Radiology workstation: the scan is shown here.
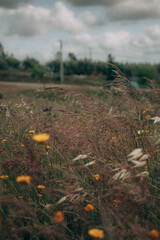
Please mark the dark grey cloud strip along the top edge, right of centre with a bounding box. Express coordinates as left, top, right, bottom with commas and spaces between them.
66, 0, 126, 7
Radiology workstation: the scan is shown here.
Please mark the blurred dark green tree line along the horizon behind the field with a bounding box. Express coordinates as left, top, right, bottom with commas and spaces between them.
0, 43, 160, 84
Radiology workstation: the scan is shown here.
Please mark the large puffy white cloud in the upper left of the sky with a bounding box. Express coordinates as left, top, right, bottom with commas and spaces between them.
0, 2, 86, 37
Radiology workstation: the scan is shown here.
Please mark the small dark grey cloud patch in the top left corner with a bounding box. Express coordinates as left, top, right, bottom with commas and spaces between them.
0, 0, 33, 8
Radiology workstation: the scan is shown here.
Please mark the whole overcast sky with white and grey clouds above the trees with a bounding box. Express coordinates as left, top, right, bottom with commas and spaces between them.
0, 0, 160, 63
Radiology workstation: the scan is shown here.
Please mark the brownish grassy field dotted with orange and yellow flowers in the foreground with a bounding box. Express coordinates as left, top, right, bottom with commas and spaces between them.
0, 73, 160, 240
